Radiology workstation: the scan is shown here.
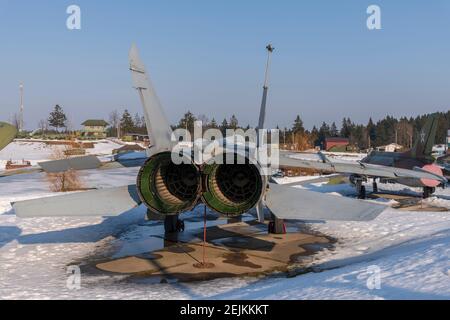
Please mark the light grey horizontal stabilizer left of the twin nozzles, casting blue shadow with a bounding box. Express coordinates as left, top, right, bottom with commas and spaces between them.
12, 185, 141, 218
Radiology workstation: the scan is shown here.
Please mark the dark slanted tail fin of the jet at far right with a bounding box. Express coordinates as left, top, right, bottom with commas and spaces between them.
411, 113, 439, 158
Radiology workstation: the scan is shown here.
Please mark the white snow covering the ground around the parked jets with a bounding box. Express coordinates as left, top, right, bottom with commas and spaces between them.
0, 144, 450, 300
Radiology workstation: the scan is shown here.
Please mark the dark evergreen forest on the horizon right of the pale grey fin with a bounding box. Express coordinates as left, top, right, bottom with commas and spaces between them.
172, 111, 450, 150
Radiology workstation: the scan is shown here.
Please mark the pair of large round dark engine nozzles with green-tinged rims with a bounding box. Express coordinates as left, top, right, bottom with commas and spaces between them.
137, 152, 267, 216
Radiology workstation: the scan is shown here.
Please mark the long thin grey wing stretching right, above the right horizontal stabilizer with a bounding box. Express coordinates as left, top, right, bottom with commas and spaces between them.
279, 152, 448, 184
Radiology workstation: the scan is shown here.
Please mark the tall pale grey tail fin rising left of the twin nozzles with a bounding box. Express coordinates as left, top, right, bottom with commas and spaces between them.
129, 44, 172, 156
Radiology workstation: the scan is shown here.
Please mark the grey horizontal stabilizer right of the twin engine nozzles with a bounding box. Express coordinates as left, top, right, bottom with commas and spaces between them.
266, 183, 387, 221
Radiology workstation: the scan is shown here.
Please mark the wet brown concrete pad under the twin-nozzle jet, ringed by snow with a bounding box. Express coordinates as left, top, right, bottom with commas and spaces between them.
97, 222, 330, 281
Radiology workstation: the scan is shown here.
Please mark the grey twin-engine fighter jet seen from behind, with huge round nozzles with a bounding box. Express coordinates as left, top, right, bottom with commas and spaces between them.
13, 46, 386, 230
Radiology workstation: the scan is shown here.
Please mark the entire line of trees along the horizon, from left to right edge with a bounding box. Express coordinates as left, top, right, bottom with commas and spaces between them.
33, 105, 450, 150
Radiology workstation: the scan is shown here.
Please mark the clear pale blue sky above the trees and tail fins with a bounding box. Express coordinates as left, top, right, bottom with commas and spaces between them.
0, 0, 450, 128
